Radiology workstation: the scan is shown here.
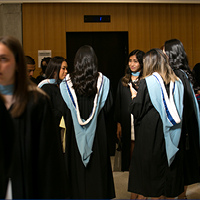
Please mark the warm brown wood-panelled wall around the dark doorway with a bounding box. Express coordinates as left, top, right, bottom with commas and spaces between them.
22, 3, 200, 76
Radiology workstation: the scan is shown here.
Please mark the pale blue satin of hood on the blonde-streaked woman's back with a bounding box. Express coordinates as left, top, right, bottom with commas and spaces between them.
145, 76, 184, 166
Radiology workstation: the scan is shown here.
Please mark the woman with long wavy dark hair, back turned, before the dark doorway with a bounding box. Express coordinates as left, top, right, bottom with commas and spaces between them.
60, 45, 115, 199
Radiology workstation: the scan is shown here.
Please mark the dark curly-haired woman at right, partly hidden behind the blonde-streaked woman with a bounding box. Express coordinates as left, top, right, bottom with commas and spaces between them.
164, 39, 200, 199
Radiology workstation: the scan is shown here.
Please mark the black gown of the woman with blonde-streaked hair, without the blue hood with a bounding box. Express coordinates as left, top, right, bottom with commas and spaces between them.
128, 79, 184, 197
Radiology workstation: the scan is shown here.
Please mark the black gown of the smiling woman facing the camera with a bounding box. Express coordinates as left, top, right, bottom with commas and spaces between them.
114, 79, 132, 171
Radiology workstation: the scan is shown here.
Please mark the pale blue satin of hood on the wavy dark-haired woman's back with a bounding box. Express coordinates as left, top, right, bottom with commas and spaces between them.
60, 75, 110, 167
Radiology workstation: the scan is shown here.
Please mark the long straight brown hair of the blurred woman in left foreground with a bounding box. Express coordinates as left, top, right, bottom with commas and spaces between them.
0, 36, 32, 117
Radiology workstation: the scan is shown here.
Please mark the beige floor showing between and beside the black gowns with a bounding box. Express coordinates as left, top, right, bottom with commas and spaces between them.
111, 156, 200, 199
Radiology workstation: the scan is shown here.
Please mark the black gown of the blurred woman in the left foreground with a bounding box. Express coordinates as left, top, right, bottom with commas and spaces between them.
11, 89, 68, 199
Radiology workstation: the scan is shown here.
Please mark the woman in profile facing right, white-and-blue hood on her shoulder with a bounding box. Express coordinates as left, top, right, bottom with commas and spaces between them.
38, 56, 68, 145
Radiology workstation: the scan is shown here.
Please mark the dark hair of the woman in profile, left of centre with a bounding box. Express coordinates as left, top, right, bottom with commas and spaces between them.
46, 56, 67, 85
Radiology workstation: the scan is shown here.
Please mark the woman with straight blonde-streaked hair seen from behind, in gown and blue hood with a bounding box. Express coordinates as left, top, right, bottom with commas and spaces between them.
128, 49, 184, 198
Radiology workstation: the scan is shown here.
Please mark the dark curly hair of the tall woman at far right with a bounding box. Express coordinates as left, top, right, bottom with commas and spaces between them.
164, 39, 195, 85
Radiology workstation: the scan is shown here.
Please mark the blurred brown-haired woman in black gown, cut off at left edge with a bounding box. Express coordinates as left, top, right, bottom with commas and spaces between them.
0, 36, 67, 199
